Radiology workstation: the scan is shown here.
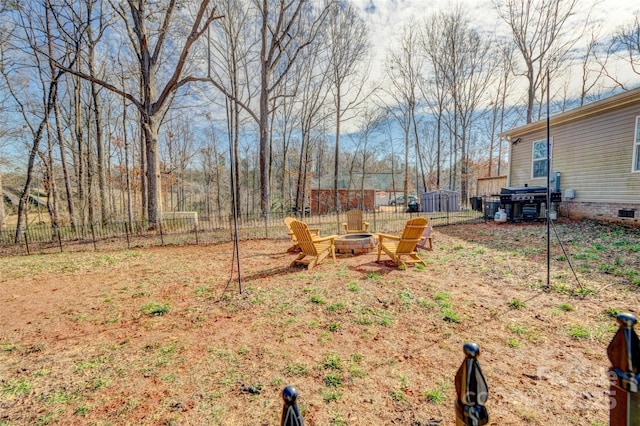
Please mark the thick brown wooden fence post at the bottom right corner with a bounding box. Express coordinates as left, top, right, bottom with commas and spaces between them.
607, 313, 640, 426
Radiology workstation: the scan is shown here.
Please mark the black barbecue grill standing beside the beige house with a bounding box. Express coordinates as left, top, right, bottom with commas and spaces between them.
500, 186, 562, 222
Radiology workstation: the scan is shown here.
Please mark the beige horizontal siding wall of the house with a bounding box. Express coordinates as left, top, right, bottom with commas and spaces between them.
504, 89, 640, 223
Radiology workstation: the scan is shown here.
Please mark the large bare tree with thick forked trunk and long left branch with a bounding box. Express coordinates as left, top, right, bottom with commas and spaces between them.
49, 0, 222, 228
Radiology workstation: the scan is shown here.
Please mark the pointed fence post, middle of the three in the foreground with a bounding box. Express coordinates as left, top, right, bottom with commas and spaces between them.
455, 343, 489, 426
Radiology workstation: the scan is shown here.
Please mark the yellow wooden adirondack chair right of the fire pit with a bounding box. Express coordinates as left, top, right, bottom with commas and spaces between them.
376, 217, 429, 267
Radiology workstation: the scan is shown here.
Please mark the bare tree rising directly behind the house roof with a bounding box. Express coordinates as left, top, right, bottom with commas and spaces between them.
494, 0, 582, 123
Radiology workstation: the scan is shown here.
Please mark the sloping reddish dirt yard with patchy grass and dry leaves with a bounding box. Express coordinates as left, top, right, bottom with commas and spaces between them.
0, 223, 640, 426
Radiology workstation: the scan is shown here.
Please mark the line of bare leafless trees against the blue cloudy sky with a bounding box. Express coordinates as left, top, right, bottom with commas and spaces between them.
0, 0, 640, 240
